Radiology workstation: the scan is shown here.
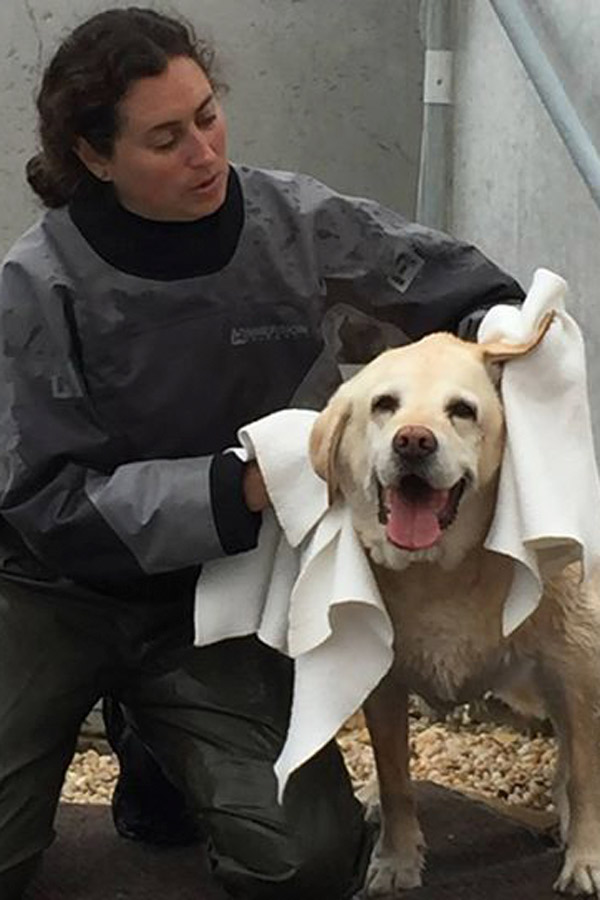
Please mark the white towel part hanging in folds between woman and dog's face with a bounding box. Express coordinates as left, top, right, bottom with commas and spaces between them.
195, 410, 393, 797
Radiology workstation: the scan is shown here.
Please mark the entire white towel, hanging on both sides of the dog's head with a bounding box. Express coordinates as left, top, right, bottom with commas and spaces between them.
195, 270, 600, 795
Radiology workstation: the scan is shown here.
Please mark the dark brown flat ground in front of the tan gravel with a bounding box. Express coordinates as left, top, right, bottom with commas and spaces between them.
26, 782, 560, 900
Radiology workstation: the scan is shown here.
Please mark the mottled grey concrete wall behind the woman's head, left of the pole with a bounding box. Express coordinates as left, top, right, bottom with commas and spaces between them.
0, 0, 422, 254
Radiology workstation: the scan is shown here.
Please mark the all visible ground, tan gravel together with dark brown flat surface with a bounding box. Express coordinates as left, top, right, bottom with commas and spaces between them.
26, 709, 561, 900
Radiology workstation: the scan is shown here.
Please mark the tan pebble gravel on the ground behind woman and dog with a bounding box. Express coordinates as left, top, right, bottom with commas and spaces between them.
62, 707, 556, 810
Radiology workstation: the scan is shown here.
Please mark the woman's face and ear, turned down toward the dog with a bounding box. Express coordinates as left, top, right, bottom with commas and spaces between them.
77, 56, 228, 221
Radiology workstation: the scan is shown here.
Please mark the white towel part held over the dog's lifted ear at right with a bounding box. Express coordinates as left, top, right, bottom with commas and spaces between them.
478, 269, 600, 634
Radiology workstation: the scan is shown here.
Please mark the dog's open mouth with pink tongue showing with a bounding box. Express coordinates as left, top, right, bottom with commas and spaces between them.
379, 475, 467, 550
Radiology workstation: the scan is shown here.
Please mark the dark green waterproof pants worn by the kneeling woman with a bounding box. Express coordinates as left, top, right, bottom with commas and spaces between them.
0, 582, 368, 900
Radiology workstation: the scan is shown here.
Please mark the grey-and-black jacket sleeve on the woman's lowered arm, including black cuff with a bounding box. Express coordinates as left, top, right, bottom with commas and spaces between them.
0, 260, 260, 583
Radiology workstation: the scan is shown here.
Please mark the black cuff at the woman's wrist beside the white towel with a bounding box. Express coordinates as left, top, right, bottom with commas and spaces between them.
210, 453, 262, 555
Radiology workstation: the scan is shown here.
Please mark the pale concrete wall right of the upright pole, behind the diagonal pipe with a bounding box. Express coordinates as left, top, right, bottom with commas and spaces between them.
452, 0, 600, 432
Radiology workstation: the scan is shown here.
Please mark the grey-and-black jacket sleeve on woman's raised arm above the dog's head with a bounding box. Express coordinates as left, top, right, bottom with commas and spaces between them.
300, 179, 524, 340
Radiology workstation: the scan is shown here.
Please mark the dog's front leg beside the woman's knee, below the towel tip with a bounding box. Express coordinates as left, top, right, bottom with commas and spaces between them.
365, 671, 425, 897
